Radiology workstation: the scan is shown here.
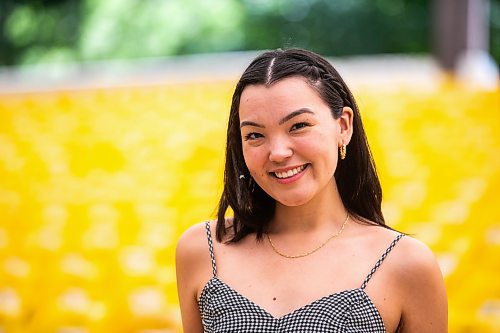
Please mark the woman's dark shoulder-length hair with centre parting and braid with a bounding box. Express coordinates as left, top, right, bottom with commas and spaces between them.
216, 49, 388, 243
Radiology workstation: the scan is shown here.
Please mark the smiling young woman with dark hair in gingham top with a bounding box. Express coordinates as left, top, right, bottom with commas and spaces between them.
176, 49, 447, 333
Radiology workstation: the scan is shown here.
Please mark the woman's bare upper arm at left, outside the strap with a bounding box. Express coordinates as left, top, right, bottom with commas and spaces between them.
175, 220, 210, 333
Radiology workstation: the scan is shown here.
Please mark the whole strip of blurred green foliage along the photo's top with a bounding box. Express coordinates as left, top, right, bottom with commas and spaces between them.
0, 0, 499, 65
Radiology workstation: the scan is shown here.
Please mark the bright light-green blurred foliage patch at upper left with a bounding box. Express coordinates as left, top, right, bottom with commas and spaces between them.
80, 0, 243, 59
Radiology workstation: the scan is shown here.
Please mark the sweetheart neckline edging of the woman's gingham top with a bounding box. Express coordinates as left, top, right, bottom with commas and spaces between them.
198, 276, 386, 331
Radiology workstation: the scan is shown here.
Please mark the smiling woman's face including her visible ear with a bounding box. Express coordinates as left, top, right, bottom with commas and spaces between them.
239, 77, 352, 206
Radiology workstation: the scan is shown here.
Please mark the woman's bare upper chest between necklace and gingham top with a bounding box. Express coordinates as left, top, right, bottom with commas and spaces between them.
211, 239, 376, 317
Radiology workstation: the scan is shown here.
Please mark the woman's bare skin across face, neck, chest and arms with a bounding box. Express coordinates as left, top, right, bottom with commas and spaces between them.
176, 77, 447, 333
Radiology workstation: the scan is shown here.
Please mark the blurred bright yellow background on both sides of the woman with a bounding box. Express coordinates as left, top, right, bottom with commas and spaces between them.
0, 62, 500, 333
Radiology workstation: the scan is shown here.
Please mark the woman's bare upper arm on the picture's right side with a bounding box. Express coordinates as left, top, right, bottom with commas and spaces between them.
400, 237, 448, 333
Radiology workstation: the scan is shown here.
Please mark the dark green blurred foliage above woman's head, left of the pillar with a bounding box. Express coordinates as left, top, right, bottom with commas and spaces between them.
244, 0, 431, 56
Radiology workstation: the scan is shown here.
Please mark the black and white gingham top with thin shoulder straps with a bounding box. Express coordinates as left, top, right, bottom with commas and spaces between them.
198, 222, 404, 333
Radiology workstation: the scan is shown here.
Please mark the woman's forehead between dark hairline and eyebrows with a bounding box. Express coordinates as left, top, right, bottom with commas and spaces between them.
239, 77, 329, 118
